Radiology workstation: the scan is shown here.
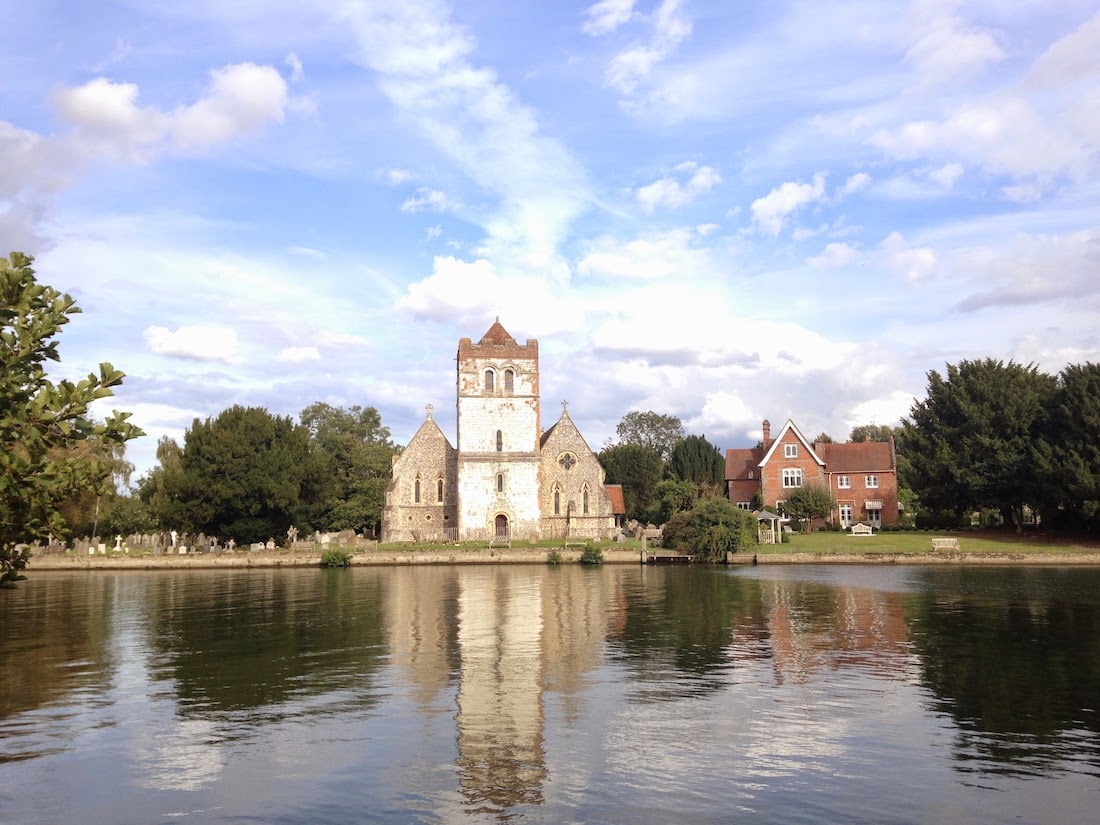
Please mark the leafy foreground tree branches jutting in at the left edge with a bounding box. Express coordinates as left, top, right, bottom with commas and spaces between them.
0, 252, 144, 584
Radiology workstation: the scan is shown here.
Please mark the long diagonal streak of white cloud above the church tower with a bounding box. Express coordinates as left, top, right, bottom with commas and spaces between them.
344, 0, 591, 278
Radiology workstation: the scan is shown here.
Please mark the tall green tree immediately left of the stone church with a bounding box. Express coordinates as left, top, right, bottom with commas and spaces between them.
299, 402, 397, 530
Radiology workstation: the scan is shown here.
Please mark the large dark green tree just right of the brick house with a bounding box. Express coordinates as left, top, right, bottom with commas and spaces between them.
903, 359, 1057, 526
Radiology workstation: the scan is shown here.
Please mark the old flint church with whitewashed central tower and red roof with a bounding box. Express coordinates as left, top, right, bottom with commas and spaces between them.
382, 319, 623, 541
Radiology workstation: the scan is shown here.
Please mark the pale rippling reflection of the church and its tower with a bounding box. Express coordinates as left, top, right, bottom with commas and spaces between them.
385, 567, 620, 814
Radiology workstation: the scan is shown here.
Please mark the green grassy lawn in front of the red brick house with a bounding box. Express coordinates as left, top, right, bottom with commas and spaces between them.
757, 530, 1100, 556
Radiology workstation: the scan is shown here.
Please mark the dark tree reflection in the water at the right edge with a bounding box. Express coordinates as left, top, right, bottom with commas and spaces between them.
909, 570, 1100, 773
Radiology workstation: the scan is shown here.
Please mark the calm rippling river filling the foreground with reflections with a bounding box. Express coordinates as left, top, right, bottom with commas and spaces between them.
0, 564, 1100, 825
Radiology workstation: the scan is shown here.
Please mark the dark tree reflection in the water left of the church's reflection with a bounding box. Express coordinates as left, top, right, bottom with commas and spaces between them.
149, 570, 384, 716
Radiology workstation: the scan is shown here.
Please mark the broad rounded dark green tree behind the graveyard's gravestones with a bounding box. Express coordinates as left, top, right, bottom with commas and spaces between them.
150, 406, 325, 545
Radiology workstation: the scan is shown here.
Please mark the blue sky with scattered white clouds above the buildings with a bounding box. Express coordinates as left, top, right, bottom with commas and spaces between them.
0, 0, 1100, 476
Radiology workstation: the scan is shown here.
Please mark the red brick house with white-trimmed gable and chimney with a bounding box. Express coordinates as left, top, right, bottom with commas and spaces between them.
726, 419, 898, 527
